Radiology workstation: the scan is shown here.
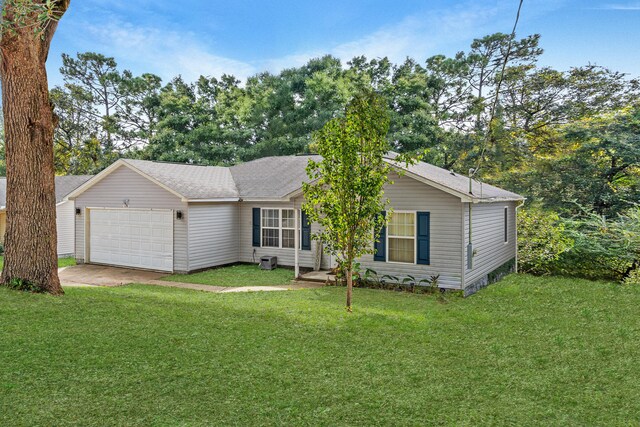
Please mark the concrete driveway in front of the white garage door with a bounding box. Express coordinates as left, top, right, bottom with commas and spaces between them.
58, 264, 167, 286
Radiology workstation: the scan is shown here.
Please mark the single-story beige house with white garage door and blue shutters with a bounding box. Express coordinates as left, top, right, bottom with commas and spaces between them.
68, 154, 524, 293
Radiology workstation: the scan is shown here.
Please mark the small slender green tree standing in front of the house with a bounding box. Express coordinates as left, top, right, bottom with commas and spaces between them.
303, 92, 391, 311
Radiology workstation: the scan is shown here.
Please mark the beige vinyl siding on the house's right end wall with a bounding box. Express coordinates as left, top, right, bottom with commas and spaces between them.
464, 202, 516, 286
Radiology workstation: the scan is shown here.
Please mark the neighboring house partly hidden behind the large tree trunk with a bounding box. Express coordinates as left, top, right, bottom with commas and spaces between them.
0, 175, 93, 257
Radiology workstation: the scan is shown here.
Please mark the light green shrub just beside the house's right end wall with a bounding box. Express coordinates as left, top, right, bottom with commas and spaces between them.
518, 206, 573, 275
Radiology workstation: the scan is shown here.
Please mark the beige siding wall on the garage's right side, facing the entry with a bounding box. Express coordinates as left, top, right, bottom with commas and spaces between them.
189, 203, 239, 270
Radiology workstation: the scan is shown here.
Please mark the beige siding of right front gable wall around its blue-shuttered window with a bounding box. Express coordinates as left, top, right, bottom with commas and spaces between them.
360, 174, 462, 289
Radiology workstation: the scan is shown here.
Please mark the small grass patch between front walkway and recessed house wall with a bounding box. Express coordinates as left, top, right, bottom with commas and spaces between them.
162, 264, 293, 287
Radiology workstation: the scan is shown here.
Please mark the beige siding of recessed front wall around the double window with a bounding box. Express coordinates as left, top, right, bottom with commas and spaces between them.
239, 199, 329, 268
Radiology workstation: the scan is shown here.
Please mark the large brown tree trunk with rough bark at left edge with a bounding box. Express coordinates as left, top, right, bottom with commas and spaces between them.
0, 0, 69, 295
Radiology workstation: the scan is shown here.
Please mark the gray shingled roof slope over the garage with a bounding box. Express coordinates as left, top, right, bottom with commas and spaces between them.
122, 159, 239, 200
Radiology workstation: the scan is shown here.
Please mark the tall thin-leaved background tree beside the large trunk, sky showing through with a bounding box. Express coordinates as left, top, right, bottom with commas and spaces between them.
51, 52, 162, 174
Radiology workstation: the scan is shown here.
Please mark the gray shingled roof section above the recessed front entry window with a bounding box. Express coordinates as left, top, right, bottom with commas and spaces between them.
230, 155, 321, 198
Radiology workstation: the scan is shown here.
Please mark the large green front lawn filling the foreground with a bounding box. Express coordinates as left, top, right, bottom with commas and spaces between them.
0, 275, 640, 426
